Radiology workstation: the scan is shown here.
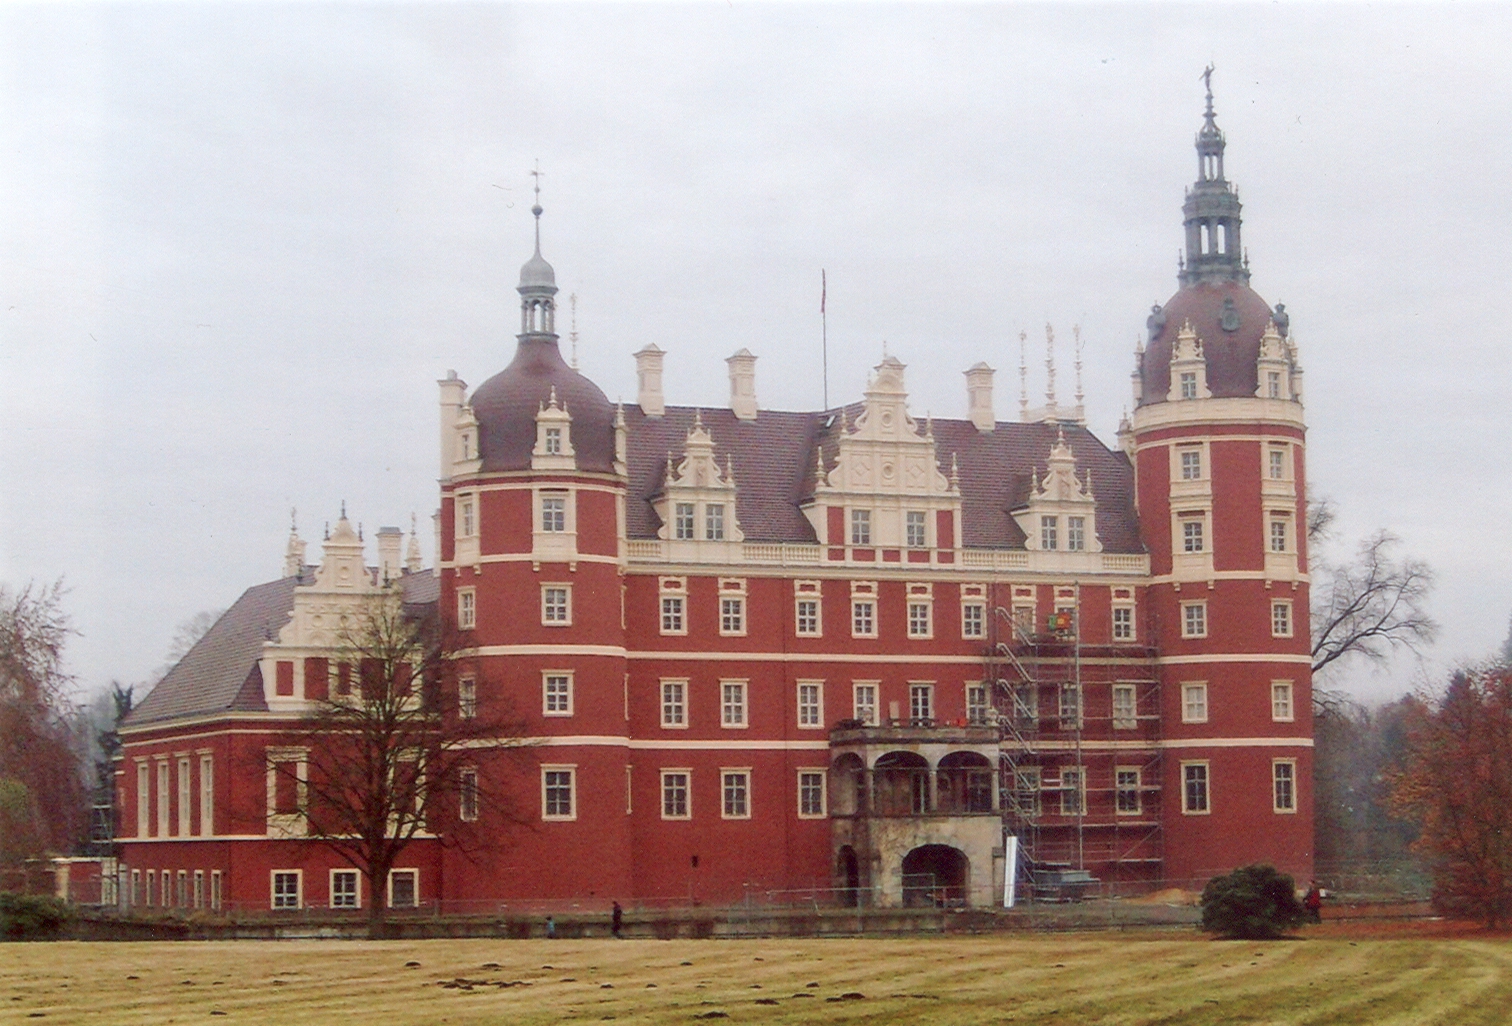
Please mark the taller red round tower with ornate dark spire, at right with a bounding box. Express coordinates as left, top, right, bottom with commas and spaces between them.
1132, 68, 1312, 887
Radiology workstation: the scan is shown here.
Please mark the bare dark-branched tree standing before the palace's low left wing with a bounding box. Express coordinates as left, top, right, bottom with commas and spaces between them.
268, 586, 525, 937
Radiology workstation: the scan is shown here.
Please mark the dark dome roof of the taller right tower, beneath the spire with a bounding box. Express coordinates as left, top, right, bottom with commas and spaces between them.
1140, 281, 1272, 406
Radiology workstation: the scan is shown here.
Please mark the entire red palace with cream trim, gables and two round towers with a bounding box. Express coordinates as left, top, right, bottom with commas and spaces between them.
119, 84, 1312, 910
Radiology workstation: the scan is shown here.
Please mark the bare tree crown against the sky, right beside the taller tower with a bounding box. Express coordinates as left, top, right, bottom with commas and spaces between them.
1312, 530, 1438, 674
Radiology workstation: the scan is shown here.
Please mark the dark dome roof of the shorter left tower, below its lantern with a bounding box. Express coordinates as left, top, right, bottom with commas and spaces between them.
472, 335, 614, 471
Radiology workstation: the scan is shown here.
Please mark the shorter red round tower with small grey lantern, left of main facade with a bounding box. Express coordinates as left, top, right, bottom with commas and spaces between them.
438, 187, 631, 898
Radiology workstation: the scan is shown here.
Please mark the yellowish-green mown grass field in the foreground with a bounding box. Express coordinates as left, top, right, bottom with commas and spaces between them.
0, 926, 1512, 1026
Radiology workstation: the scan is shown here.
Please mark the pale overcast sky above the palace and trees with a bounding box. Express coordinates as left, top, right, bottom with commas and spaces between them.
0, 3, 1512, 700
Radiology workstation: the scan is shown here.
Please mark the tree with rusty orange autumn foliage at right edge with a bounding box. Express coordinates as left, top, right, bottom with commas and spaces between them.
1391, 665, 1512, 928
